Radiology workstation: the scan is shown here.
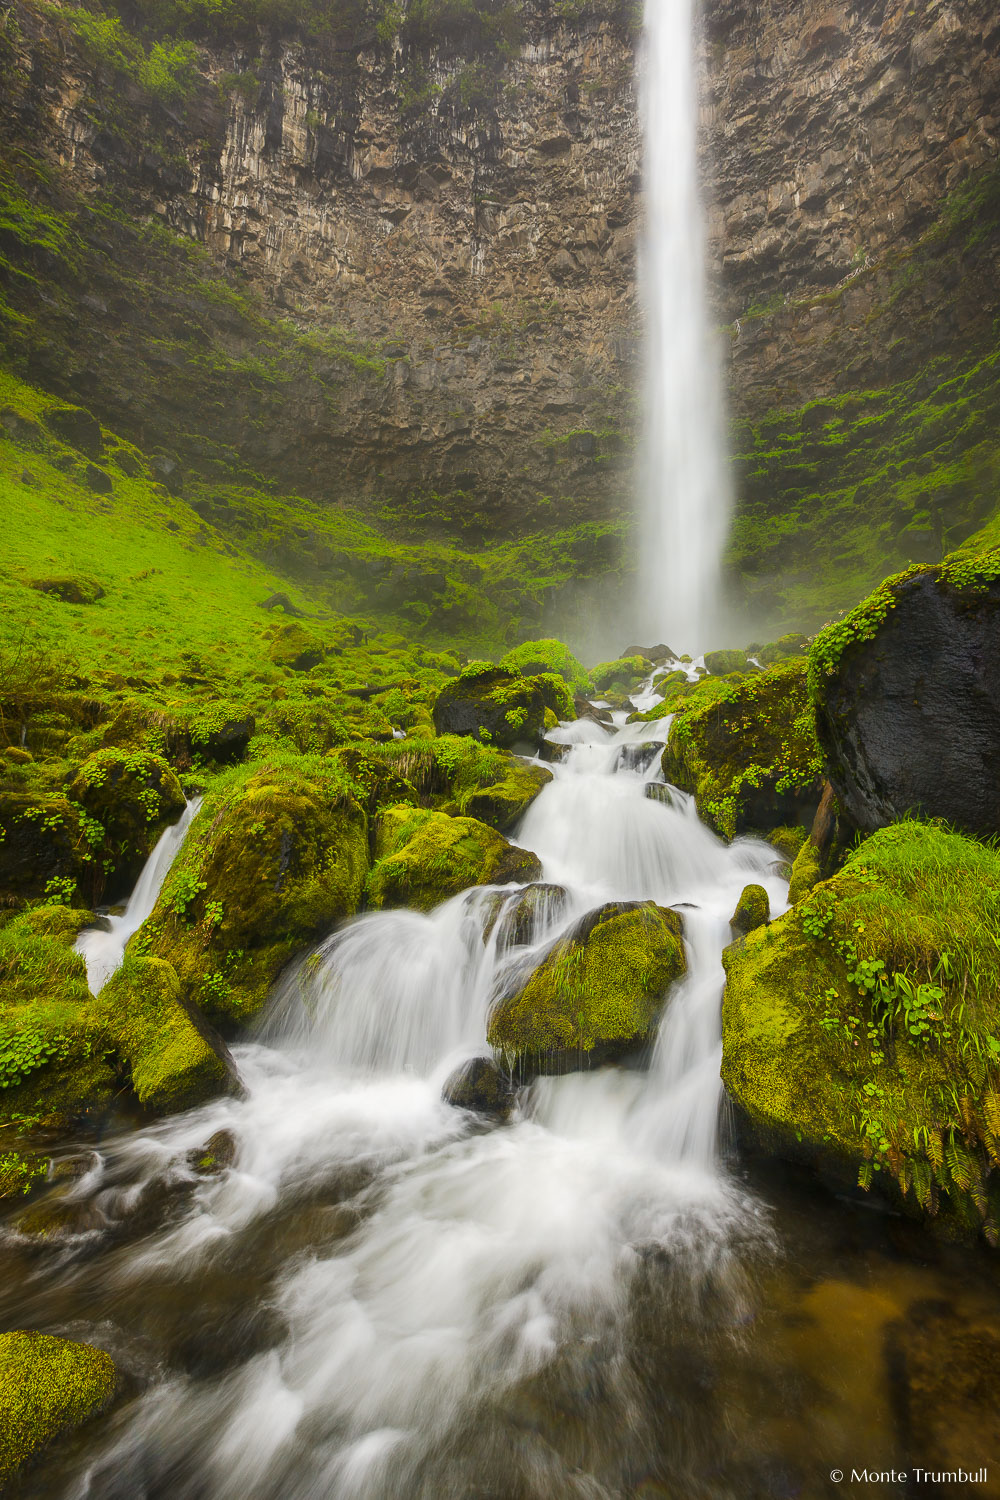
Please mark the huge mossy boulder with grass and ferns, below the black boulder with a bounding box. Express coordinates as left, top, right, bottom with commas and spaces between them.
723, 821, 1000, 1239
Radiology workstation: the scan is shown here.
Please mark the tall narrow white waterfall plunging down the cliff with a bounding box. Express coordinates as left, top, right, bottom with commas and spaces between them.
639, 0, 730, 651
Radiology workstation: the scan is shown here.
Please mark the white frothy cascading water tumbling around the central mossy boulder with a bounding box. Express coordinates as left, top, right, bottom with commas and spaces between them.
11, 669, 786, 1500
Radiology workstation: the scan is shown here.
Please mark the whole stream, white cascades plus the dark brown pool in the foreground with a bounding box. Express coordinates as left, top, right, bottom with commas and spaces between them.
0, 663, 1000, 1500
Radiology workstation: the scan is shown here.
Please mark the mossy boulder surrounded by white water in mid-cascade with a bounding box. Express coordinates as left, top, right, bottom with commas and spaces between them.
487, 902, 685, 1073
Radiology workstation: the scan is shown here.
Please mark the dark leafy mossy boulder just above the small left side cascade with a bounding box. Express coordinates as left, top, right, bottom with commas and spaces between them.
69, 749, 186, 900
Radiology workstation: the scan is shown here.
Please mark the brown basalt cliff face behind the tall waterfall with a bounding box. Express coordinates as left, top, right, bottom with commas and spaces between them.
3, 0, 1000, 585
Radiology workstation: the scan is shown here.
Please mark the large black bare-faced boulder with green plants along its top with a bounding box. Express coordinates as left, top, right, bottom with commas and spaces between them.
810, 549, 1000, 836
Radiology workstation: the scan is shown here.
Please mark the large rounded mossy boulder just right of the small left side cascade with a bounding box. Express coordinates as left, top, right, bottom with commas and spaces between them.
142, 755, 369, 1029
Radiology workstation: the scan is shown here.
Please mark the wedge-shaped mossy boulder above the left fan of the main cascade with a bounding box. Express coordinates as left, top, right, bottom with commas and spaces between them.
367, 807, 541, 912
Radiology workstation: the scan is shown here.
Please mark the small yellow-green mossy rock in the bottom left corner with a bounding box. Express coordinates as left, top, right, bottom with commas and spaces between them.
0, 1331, 118, 1484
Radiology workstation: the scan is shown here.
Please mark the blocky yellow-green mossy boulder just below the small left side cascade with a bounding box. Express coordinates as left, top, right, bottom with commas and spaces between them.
97, 956, 238, 1115
